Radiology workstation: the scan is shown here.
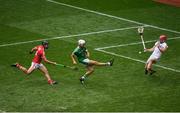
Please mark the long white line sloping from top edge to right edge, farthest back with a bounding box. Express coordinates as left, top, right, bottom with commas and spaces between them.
46, 0, 180, 34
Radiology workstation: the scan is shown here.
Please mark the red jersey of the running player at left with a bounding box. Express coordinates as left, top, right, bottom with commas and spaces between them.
32, 45, 46, 64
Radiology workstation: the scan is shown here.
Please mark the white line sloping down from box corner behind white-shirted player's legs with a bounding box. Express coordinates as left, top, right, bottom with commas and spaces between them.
96, 49, 180, 73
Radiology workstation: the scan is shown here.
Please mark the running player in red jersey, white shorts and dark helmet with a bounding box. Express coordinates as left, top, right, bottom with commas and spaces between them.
11, 41, 57, 85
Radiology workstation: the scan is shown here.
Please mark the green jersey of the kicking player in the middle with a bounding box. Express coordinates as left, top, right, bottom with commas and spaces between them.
73, 46, 87, 62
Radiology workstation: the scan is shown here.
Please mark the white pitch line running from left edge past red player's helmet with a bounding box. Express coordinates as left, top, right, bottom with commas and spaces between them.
0, 26, 140, 47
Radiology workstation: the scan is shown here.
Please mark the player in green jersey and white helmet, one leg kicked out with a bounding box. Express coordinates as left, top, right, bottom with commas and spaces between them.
71, 40, 114, 84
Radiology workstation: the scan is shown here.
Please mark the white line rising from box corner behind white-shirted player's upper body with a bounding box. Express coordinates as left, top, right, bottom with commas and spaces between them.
95, 37, 180, 50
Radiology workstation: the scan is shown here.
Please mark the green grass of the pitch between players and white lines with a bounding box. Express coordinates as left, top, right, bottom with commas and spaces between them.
0, 0, 180, 112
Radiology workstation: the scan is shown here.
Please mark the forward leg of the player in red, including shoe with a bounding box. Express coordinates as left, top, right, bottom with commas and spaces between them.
39, 65, 57, 85
